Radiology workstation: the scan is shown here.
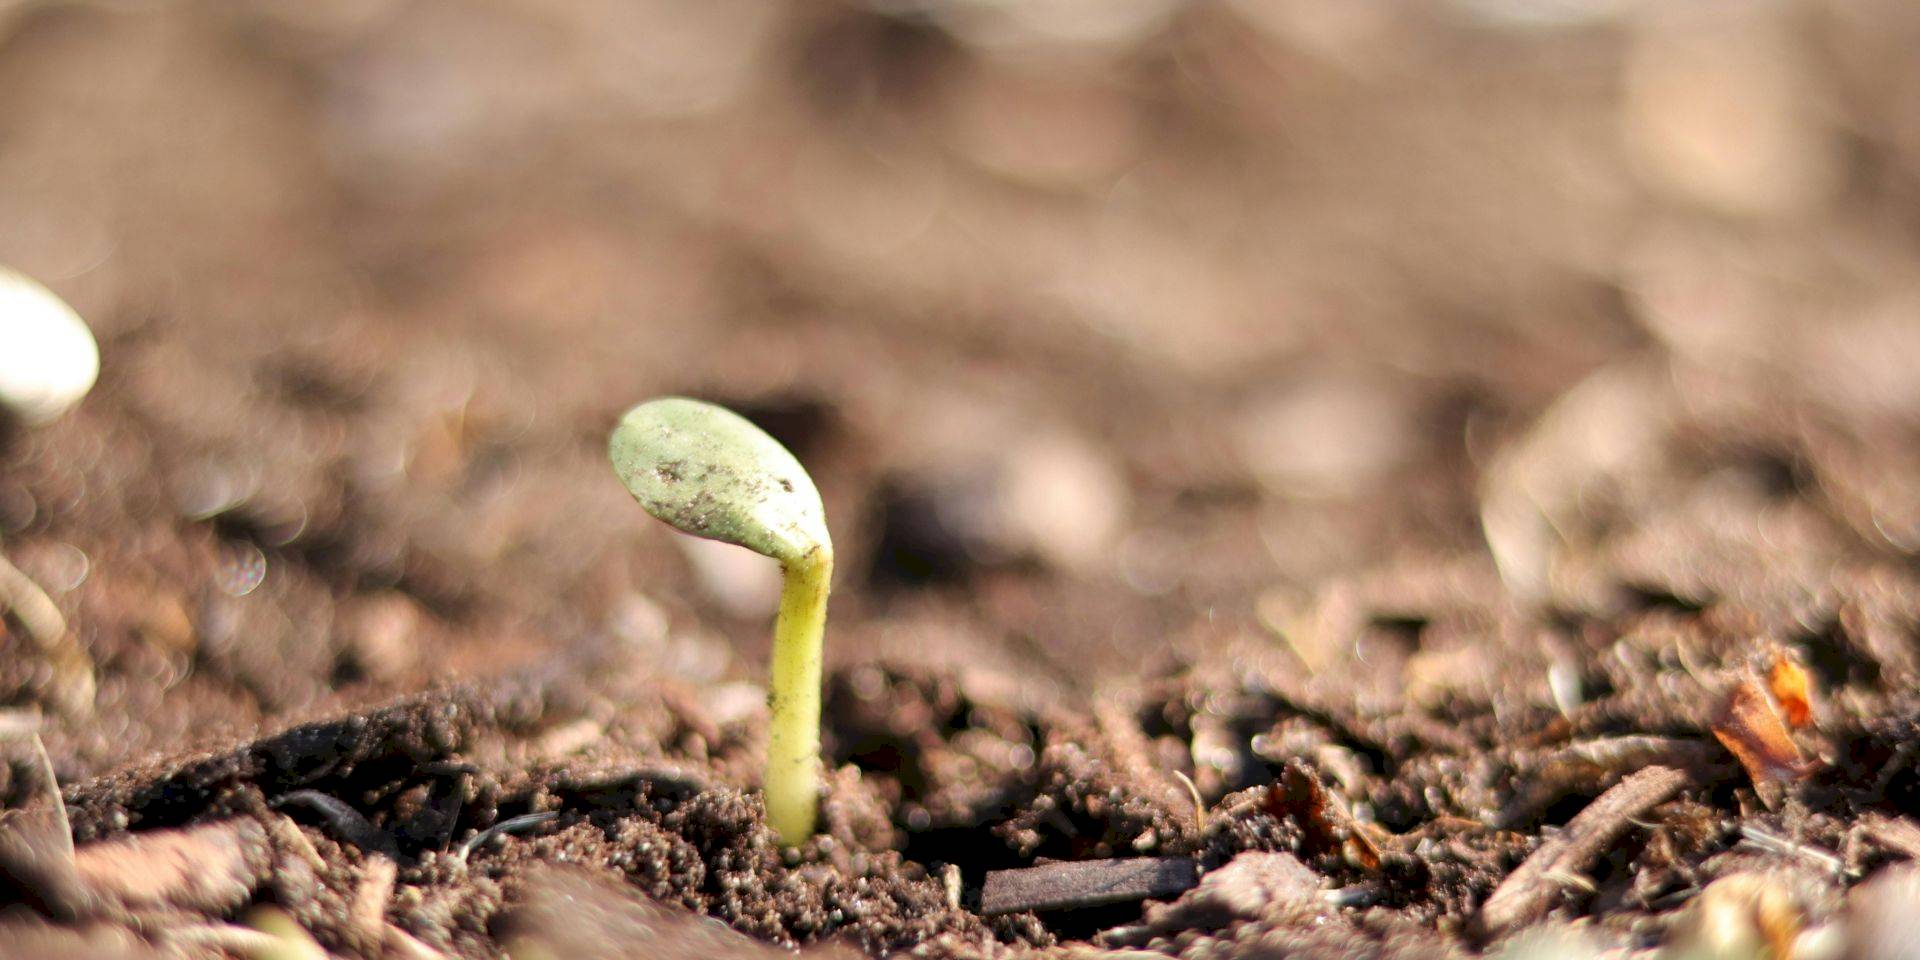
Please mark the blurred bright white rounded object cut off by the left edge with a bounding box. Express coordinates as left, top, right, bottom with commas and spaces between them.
0, 267, 100, 424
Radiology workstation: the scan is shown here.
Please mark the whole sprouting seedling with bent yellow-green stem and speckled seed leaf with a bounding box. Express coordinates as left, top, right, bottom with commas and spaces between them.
607, 397, 833, 845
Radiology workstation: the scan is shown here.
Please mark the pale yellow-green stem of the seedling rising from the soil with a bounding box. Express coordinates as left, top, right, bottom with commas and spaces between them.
764, 547, 833, 847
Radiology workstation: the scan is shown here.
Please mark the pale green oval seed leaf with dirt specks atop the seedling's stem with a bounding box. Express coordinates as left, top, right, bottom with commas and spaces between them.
607, 397, 833, 564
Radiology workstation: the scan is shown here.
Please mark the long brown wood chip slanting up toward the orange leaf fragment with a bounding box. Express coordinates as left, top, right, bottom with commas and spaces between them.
1480, 766, 1693, 935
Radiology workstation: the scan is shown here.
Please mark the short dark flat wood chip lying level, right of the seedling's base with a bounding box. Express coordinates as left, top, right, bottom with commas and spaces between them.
979, 856, 1200, 916
